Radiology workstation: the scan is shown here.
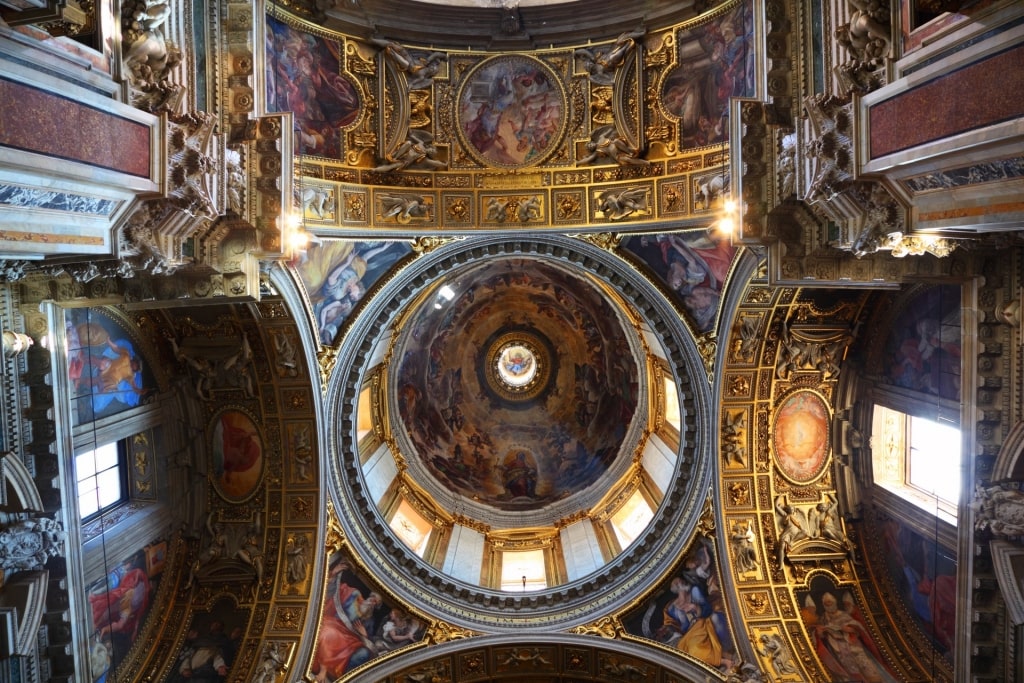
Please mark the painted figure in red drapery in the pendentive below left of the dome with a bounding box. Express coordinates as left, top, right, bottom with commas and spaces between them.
312, 558, 381, 683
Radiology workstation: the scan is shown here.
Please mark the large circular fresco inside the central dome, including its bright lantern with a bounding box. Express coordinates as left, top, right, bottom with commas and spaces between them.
393, 258, 639, 511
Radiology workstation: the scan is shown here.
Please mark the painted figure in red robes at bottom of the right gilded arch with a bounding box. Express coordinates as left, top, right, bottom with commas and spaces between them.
809, 593, 898, 683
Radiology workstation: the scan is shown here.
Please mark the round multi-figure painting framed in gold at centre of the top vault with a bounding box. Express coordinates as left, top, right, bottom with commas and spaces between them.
459, 55, 565, 168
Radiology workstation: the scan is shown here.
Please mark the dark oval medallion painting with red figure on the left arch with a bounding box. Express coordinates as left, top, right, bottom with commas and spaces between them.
210, 409, 263, 502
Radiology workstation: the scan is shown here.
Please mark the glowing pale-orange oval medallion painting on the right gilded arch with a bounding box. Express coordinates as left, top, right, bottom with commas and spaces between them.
772, 390, 828, 483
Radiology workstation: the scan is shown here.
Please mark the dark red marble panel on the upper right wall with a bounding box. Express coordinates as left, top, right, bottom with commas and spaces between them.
869, 46, 1024, 159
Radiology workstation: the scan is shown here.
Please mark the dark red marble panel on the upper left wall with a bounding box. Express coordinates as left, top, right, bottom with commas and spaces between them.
0, 79, 152, 178
